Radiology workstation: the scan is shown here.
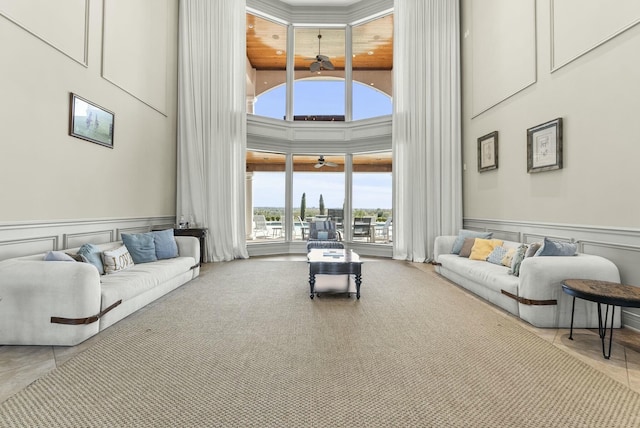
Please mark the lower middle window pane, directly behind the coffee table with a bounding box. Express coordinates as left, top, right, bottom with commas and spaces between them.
293, 155, 344, 240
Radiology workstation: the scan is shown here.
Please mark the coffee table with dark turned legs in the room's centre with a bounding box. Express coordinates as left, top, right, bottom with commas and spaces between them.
307, 248, 362, 299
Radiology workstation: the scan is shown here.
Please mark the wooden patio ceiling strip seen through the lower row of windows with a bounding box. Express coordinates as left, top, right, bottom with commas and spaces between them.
246, 151, 392, 172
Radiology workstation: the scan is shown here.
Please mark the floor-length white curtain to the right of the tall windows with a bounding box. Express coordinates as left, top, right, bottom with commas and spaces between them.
393, 0, 462, 262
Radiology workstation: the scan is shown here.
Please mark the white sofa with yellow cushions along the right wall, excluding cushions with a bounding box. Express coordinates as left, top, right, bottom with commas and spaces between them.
433, 236, 620, 328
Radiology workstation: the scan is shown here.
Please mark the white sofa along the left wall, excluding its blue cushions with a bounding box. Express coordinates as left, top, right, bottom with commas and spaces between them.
0, 236, 200, 346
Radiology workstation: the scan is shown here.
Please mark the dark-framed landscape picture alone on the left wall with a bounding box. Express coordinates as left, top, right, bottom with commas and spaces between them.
69, 93, 115, 148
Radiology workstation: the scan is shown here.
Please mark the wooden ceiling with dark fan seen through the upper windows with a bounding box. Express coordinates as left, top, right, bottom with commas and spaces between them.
246, 14, 393, 70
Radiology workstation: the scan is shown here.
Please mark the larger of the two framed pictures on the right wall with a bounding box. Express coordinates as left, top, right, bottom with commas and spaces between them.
527, 117, 562, 172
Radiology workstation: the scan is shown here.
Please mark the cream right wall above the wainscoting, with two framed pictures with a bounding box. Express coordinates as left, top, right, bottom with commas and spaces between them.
462, 0, 640, 229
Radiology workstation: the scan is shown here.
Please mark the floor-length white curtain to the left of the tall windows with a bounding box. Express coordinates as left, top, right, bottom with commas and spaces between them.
176, 0, 249, 261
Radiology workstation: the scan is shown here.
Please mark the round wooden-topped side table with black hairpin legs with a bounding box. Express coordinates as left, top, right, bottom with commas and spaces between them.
562, 279, 640, 360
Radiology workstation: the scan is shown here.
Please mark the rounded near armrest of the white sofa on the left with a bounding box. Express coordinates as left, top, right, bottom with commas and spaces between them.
0, 260, 101, 345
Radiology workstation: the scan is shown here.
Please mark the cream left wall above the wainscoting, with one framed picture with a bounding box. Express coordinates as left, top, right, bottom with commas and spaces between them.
0, 0, 178, 225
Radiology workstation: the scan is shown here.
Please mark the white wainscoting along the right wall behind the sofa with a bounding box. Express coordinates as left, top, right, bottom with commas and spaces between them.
463, 218, 640, 331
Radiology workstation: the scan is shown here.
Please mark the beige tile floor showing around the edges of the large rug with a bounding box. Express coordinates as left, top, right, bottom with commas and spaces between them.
0, 255, 640, 402
